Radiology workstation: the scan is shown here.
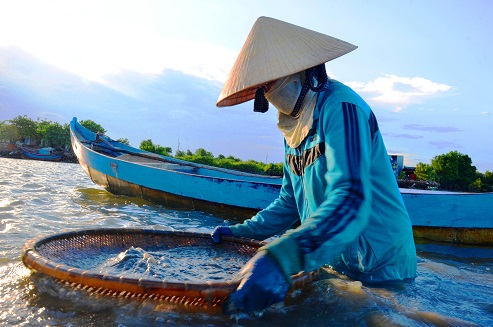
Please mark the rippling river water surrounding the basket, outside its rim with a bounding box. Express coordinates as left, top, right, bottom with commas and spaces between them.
0, 158, 493, 327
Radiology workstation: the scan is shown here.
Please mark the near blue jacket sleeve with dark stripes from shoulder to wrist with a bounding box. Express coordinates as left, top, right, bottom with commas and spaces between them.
265, 100, 373, 276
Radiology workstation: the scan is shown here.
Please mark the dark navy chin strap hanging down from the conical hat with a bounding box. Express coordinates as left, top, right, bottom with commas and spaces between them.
253, 64, 329, 118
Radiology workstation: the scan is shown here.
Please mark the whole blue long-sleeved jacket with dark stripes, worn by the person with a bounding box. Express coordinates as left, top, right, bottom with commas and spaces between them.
231, 80, 416, 282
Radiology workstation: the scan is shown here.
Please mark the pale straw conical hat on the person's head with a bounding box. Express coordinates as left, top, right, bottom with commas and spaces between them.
216, 17, 357, 107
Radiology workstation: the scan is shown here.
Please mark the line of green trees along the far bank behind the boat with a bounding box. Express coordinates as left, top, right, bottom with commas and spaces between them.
0, 115, 493, 192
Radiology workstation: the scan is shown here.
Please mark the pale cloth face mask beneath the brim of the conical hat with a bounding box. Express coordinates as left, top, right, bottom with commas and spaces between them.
265, 72, 305, 115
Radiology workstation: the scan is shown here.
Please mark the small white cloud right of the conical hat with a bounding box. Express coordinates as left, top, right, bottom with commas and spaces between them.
346, 74, 452, 107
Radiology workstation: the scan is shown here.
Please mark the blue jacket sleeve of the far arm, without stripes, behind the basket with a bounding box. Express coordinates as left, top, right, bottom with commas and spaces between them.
230, 162, 299, 240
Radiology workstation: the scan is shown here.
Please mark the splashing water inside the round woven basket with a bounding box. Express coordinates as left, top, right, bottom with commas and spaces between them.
67, 245, 251, 283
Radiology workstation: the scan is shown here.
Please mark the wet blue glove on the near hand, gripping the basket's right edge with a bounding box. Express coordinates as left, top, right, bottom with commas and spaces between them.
223, 251, 289, 314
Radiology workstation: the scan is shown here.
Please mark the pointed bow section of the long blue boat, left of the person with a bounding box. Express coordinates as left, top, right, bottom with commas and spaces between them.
70, 118, 282, 219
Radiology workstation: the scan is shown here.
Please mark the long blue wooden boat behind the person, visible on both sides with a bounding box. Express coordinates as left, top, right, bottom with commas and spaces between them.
70, 118, 493, 245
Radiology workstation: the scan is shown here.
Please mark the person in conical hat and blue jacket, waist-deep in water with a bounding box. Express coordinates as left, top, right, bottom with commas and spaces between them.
212, 17, 416, 313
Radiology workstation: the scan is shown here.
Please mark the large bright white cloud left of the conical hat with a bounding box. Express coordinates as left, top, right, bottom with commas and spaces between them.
0, 0, 236, 86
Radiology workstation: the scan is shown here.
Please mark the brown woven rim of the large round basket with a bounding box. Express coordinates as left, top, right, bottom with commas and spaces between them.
22, 228, 319, 312
